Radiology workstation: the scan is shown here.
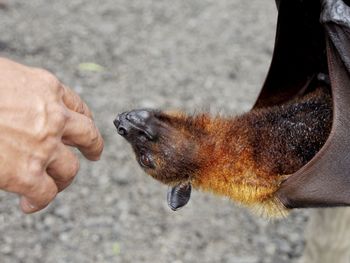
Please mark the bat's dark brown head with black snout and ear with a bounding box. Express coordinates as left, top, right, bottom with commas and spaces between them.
114, 109, 206, 210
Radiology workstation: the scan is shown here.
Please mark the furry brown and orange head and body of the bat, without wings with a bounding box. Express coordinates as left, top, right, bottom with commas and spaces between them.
114, 87, 332, 217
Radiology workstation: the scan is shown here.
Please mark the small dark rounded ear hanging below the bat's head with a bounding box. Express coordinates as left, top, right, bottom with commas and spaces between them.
167, 183, 192, 211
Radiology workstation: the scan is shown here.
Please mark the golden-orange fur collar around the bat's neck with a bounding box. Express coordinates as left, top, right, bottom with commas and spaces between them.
178, 115, 286, 216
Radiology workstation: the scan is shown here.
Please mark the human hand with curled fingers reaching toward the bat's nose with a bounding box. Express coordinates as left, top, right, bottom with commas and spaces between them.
0, 58, 103, 213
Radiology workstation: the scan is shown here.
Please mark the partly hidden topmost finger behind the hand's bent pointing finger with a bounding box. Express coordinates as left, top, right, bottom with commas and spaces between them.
61, 84, 93, 119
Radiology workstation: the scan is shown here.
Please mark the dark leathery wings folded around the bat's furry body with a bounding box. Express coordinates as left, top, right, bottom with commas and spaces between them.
254, 0, 350, 208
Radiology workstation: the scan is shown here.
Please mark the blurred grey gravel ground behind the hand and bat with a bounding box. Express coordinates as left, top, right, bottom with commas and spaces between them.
0, 0, 307, 263
